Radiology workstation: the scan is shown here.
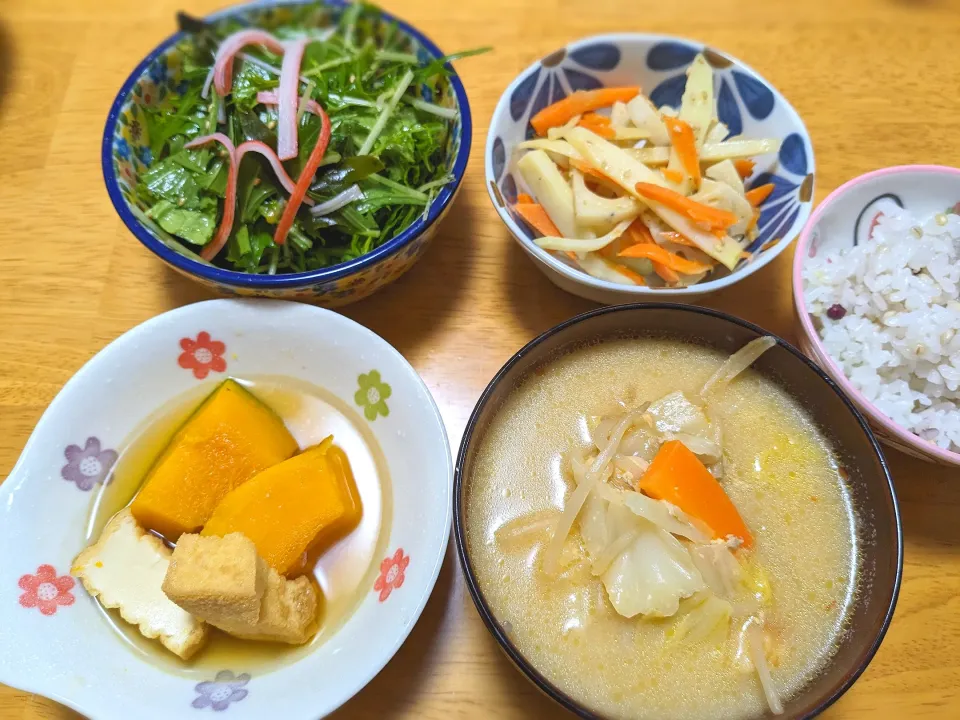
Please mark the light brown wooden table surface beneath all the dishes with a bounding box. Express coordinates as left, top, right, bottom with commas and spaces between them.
0, 0, 960, 720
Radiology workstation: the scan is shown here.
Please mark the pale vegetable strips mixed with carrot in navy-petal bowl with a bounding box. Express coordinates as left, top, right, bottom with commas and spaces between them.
514, 55, 780, 287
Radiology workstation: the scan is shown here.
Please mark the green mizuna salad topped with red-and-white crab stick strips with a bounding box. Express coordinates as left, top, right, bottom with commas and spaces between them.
137, 4, 484, 274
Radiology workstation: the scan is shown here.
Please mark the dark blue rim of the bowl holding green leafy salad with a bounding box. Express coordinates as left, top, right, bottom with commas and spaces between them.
100, 0, 473, 289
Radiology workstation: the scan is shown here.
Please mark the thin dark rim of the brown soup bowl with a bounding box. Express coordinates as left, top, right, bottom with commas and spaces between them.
453, 302, 903, 720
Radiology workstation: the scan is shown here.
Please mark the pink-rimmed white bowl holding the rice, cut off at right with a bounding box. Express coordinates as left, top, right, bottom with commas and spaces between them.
793, 165, 960, 467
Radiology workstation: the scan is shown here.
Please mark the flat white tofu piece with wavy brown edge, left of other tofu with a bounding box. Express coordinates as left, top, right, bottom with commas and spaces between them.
70, 508, 209, 660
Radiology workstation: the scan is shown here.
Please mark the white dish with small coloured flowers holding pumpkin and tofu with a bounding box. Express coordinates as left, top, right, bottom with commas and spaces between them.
0, 299, 453, 720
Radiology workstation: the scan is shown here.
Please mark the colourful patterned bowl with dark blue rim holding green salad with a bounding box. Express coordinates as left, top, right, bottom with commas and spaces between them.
101, 0, 473, 307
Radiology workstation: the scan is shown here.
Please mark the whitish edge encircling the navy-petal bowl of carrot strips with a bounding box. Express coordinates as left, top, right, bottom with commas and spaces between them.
484, 33, 816, 297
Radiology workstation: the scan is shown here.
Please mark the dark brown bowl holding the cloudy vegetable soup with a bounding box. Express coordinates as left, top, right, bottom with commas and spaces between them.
454, 303, 903, 718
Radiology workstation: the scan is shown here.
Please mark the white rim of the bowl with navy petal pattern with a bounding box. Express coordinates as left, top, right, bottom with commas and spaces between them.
483, 32, 817, 302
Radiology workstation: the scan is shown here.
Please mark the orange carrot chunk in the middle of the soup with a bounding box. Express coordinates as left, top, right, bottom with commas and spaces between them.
639, 440, 753, 548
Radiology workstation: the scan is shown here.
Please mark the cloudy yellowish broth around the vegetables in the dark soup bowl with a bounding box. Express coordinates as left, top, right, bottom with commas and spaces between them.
464, 339, 857, 720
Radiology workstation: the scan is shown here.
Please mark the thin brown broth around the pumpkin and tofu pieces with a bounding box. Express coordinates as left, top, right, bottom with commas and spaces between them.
84, 376, 393, 679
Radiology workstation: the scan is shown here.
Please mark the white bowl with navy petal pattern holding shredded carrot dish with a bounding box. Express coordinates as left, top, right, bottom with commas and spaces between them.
484, 33, 814, 304
